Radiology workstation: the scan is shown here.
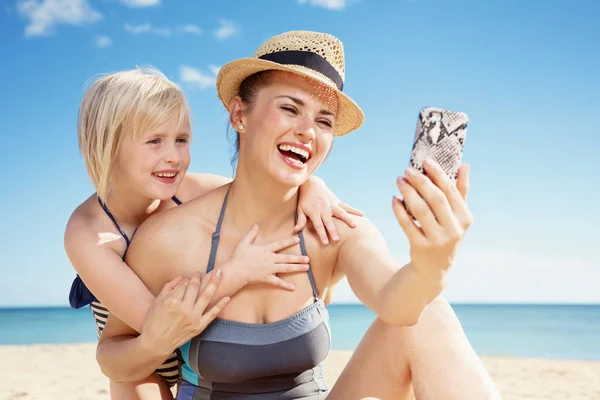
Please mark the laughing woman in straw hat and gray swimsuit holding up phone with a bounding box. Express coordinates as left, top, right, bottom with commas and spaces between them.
97, 31, 498, 400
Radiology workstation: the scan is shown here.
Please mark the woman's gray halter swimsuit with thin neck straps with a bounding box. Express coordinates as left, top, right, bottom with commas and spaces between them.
177, 194, 331, 400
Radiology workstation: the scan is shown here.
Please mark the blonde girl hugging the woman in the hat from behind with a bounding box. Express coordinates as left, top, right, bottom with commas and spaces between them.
65, 69, 366, 399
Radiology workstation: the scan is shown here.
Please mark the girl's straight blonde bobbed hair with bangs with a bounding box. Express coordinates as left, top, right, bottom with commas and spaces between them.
77, 68, 190, 199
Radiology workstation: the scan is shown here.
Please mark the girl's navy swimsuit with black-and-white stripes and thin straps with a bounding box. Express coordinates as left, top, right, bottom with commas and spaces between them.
69, 196, 181, 386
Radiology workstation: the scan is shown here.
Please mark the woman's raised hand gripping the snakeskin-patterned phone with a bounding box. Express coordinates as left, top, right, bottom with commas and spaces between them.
393, 160, 473, 281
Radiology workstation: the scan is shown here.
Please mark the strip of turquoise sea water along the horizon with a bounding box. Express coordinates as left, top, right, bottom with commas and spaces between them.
0, 304, 600, 360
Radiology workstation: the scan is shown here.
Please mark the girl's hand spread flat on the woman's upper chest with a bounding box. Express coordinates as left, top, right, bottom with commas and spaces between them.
223, 225, 310, 291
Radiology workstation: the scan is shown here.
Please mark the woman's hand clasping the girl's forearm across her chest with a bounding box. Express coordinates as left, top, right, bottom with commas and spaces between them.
140, 270, 229, 356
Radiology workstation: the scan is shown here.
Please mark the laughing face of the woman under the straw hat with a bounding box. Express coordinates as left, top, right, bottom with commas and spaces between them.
232, 71, 338, 187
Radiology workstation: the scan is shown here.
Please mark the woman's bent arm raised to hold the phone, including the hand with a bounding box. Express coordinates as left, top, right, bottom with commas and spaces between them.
335, 164, 472, 326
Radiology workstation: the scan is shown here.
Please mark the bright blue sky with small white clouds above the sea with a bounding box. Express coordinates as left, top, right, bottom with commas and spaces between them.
0, 0, 600, 306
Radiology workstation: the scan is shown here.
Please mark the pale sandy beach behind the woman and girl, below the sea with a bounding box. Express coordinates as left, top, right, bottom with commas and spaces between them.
0, 344, 600, 400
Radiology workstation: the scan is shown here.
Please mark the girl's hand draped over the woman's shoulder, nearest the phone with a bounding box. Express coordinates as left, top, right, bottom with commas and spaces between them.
294, 176, 364, 245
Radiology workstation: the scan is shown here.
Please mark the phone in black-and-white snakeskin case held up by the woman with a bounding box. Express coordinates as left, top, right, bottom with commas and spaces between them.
410, 107, 468, 179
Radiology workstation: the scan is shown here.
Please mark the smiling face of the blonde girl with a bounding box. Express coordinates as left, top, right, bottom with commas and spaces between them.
113, 113, 191, 200
